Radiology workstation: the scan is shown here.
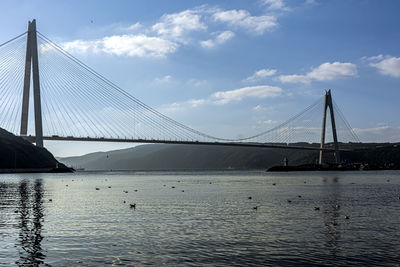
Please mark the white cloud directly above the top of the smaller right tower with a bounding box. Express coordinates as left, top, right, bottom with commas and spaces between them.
278, 62, 357, 84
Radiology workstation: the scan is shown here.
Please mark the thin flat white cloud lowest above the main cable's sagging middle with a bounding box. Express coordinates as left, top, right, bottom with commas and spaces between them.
211, 85, 282, 105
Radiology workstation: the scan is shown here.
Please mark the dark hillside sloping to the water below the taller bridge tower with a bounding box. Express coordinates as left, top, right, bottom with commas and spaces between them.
0, 128, 68, 170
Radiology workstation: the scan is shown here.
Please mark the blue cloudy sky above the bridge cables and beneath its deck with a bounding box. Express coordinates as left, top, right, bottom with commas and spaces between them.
0, 0, 400, 156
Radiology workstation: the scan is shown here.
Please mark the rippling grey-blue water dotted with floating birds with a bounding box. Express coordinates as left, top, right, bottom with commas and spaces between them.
0, 171, 400, 266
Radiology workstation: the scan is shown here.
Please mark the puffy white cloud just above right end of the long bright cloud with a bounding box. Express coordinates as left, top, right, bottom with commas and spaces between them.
152, 9, 207, 42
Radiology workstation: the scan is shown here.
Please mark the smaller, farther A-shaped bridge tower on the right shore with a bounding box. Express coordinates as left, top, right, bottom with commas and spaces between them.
318, 89, 340, 164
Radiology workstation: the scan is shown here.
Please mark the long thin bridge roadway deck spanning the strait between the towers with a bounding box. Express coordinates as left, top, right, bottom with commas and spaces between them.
21, 135, 349, 152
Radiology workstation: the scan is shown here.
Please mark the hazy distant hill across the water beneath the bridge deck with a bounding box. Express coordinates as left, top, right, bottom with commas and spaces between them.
59, 144, 316, 170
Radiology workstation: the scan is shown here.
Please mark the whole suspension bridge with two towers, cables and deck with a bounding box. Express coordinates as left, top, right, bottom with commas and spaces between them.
0, 20, 359, 163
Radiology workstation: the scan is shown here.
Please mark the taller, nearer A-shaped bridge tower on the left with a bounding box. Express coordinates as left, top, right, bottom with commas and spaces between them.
20, 20, 43, 147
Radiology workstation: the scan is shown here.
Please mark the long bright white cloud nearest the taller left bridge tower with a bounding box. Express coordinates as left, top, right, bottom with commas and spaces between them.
62, 34, 178, 58
